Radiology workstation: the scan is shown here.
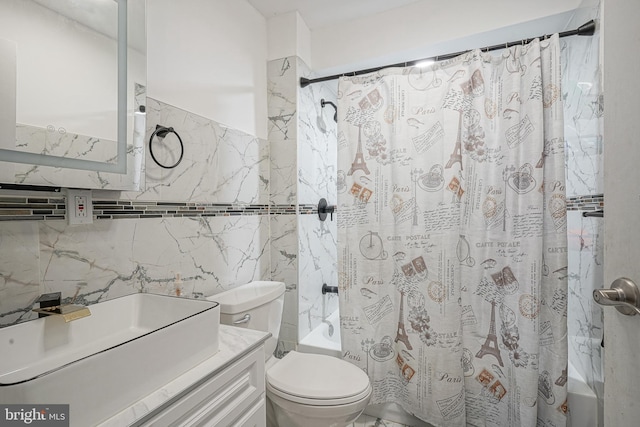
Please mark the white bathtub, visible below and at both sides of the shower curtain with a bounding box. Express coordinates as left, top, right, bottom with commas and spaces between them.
298, 310, 598, 427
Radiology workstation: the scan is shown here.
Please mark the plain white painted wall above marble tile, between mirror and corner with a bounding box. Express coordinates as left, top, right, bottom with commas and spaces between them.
147, 0, 267, 138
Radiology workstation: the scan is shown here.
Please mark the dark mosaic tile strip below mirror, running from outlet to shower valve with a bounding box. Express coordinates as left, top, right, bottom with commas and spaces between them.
0, 195, 318, 221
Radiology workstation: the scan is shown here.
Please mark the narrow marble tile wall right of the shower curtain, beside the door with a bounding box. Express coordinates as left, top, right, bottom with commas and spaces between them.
562, 0, 604, 425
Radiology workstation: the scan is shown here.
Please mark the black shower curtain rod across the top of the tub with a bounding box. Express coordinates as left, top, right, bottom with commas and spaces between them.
300, 20, 596, 88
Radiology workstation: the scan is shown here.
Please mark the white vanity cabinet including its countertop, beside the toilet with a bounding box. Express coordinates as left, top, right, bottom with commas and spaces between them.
99, 325, 271, 427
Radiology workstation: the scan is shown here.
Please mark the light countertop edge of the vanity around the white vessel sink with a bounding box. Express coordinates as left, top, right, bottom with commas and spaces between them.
99, 325, 271, 427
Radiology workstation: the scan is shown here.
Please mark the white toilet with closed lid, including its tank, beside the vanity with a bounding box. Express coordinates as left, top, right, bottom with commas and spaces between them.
208, 281, 371, 427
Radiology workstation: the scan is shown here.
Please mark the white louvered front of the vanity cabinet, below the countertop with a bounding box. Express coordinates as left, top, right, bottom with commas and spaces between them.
134, 346, 266, 427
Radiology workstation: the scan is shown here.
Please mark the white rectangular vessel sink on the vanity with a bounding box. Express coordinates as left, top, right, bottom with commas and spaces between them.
0, 294, 220, 427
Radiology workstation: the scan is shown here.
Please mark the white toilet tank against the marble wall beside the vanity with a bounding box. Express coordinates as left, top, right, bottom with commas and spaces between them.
207, 281, 285, 358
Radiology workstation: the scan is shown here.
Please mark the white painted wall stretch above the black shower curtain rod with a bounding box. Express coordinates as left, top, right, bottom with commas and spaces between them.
310, 0, 580, 74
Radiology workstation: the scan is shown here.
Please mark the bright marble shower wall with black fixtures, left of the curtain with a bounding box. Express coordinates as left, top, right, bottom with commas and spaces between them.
297, 59, 338, 339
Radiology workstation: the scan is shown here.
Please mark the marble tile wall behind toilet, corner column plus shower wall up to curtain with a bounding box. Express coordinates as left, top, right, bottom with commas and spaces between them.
267, 57, 338, 354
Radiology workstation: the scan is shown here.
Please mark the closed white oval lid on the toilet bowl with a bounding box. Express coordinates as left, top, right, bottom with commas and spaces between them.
267, 351, 371, 405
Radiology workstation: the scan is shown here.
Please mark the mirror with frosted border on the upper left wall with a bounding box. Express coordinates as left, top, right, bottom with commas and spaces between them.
0, 0, 146, 190
